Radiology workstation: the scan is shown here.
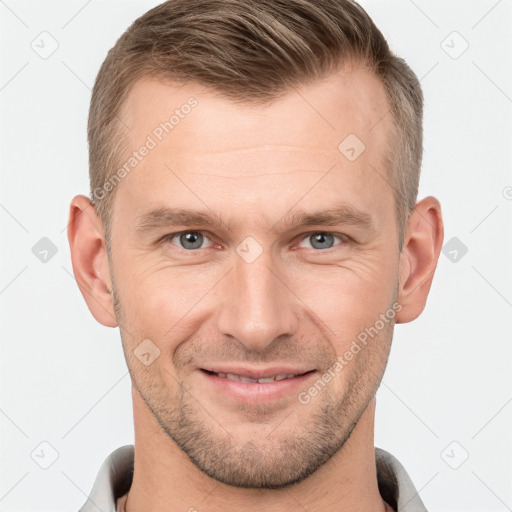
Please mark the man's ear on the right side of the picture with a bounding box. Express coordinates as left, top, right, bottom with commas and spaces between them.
396, 196, 444, 323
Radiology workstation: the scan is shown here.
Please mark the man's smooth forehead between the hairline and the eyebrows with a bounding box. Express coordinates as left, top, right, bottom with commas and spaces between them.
116, 63, 392, 230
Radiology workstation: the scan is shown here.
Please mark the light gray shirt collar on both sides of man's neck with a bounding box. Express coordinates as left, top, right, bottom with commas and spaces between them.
78, 444, 427, 512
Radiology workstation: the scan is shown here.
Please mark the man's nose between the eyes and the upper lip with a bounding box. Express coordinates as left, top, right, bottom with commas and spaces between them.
217, 247, 299, 352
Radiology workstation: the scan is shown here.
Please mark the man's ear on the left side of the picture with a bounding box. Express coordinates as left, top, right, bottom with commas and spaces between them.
68, 195, 117, 327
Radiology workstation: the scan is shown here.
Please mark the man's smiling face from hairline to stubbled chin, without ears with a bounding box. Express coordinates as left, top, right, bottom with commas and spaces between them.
110, 64, 399, 487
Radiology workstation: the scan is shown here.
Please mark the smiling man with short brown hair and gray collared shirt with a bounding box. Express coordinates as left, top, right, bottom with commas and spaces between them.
68, 0, 443, 512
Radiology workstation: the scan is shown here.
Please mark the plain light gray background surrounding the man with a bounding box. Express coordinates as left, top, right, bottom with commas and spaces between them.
0, 0, 512, 512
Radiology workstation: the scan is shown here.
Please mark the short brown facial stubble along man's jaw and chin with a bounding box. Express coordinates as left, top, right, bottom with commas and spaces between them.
112, 260, 396, 489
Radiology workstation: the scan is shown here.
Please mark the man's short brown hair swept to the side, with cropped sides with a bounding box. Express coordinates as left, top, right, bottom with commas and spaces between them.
88, 0, 423, 250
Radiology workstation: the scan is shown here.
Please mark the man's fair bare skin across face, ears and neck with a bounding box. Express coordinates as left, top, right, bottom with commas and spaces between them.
68, 61, 443, 512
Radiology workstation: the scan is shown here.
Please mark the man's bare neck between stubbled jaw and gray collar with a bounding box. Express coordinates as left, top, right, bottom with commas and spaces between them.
125, 390, 392, 512
